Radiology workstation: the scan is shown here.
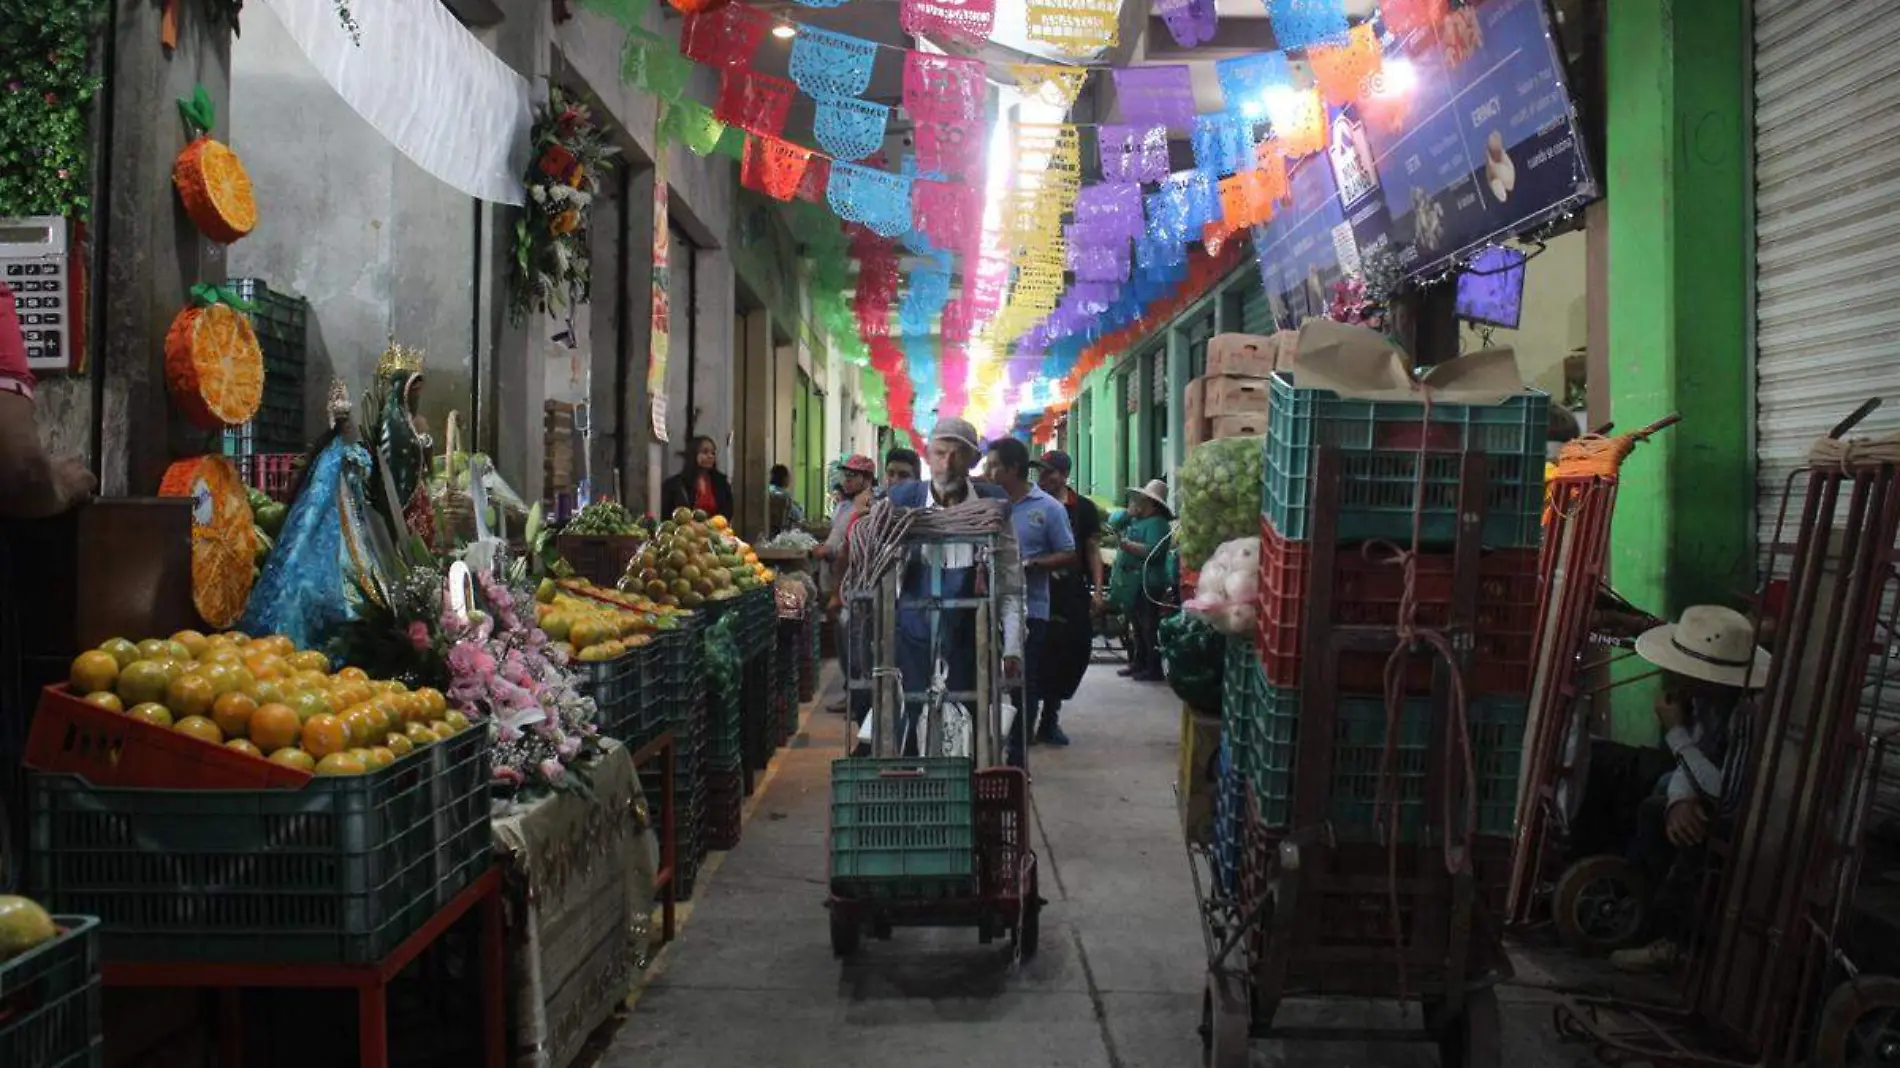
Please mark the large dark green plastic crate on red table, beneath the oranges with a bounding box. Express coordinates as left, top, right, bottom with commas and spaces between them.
29, 724, 492, 963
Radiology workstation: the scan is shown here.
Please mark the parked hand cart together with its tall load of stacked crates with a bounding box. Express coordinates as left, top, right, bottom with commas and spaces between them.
1189, 359, 1549, 1068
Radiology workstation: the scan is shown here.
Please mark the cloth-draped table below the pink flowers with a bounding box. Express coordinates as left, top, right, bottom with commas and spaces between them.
494, 735, 671, 1068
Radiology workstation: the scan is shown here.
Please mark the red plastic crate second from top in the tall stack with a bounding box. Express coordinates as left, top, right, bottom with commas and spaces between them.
1254, 517, 1541, 696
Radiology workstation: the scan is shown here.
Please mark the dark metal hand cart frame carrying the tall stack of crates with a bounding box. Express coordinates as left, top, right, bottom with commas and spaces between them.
1191, 447, 1522, 1068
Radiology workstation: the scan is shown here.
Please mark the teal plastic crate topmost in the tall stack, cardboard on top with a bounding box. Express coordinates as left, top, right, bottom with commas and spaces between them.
1260, 374, 1550, 549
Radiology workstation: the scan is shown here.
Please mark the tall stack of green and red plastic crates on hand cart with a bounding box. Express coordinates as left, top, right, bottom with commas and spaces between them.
1229, 374, 1549, 840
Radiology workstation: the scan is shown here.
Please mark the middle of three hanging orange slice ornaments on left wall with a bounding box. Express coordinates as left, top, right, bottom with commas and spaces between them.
165, 285, 264, 429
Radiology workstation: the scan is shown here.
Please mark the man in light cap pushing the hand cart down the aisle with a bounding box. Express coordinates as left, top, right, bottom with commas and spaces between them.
870, 418, 1028, 747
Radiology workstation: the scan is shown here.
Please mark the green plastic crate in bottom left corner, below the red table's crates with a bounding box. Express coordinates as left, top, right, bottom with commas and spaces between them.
0, 904, 105, 1068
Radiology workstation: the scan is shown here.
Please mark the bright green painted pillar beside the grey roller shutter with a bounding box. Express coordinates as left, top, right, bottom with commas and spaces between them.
1590, 0, 1754, 743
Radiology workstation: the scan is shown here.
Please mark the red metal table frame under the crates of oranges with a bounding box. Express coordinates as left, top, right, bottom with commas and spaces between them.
101, 867, 507, 1068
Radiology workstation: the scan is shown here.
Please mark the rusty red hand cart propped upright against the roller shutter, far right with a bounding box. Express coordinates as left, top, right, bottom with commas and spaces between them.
1554, 403, 1900, 1068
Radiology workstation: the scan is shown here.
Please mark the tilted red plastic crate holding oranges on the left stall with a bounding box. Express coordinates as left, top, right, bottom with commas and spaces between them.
21, 686, 310, 791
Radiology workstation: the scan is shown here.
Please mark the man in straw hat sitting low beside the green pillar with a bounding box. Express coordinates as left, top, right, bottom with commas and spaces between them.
1609, 604, 1771, 971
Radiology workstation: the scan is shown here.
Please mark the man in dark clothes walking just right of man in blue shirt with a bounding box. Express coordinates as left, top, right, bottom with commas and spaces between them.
1018, 448, 1108, 745
